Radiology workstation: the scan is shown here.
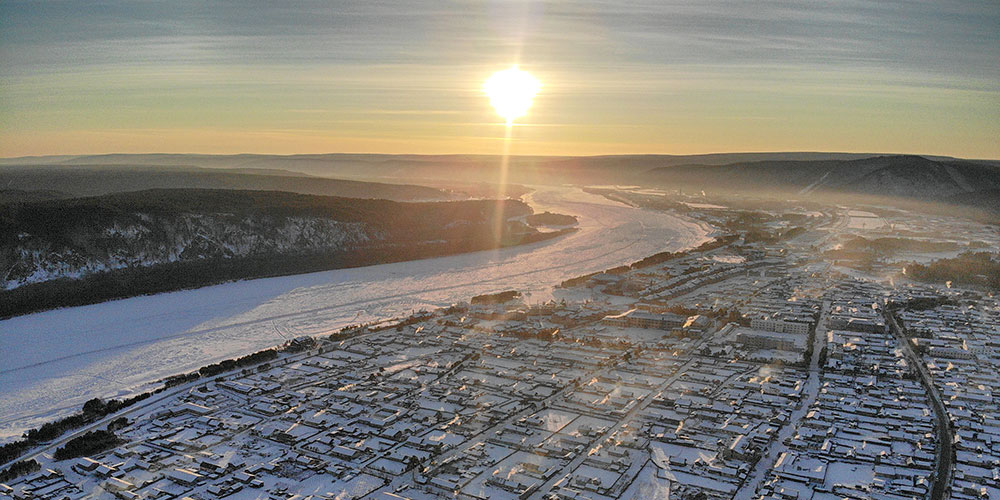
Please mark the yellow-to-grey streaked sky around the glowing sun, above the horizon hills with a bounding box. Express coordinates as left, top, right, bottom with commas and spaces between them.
0, 0, 1000, 159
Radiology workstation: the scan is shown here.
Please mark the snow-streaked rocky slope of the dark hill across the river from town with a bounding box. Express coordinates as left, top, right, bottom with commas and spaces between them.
0, 212, 376, 290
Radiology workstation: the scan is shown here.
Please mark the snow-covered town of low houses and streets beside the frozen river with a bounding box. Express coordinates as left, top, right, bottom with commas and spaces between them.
0, 192, 1000, 500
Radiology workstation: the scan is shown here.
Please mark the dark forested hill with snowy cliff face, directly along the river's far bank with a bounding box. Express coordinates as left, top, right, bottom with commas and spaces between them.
0, 189, 547, 316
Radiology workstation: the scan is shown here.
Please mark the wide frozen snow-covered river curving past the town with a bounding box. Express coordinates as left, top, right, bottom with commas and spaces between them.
0, 187, 709, 441
